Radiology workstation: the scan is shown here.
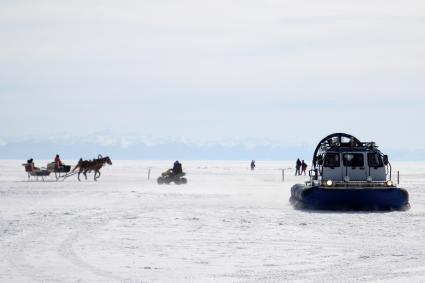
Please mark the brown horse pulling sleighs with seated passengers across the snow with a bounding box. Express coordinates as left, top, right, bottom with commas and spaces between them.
22, 154, 112, 181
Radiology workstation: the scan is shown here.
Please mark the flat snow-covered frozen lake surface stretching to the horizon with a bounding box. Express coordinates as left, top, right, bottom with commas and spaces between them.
0, 160, 425, 282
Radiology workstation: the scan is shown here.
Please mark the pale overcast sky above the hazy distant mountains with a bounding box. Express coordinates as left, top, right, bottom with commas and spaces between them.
0, 0, 425, 149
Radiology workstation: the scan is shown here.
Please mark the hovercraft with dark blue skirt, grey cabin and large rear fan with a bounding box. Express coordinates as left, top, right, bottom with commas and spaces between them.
290, 133, 410, 211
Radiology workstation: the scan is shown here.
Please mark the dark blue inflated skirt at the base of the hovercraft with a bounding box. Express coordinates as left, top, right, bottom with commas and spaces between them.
290, 184, 410, 211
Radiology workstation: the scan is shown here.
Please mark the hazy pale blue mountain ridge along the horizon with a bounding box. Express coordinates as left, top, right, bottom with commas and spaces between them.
0, 135, 425, 161
